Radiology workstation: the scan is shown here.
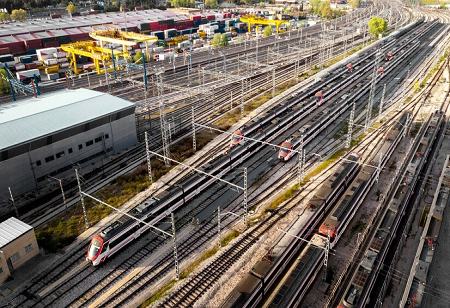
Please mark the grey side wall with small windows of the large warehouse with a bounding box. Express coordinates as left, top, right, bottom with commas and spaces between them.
0, 113, 137, 196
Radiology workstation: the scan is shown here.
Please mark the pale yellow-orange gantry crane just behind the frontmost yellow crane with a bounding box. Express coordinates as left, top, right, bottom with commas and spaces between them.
89, 25, 158, 55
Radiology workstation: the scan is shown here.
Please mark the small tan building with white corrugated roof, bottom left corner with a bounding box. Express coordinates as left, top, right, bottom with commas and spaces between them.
0, 217, 39, 284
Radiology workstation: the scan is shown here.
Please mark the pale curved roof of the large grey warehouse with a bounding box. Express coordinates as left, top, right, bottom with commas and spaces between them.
0, 89, 134, 151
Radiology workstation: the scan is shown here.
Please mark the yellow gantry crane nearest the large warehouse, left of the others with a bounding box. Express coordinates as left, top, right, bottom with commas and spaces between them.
61, 41, 129, 75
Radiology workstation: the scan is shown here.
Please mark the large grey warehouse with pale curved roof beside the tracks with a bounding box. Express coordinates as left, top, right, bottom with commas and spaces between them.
0, 89, 137, 196
